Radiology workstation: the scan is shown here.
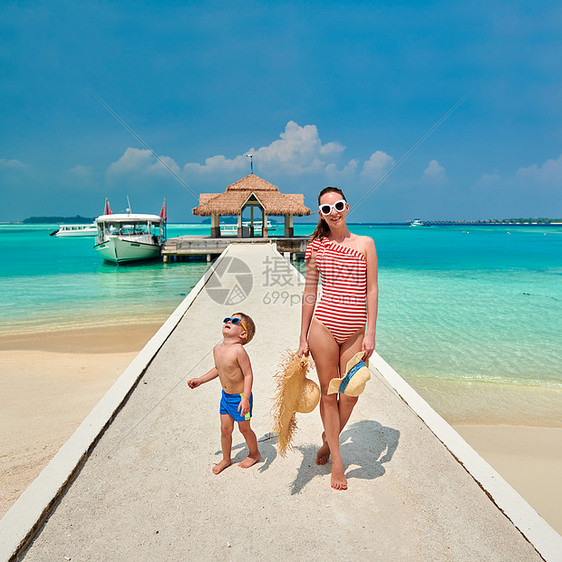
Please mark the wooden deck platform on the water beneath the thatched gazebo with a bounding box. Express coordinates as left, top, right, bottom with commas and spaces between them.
162, 236, 309, 262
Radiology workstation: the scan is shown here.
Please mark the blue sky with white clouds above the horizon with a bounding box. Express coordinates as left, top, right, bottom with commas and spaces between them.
0, 0, 562, 222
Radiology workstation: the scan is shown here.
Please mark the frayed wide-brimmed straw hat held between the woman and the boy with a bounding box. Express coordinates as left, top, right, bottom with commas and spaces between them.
271, 351, 320, 457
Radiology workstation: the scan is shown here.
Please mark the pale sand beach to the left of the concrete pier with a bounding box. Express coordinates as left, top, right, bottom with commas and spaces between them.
0, 324, 160, 516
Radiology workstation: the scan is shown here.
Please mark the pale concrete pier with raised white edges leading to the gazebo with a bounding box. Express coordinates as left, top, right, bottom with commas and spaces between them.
0, 244, 562, 561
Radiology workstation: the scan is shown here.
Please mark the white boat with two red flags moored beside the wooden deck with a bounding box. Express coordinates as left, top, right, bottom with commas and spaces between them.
94, 199, 167, 263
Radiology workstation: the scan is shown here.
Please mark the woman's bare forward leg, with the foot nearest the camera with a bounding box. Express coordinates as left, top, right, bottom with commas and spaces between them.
308, 318, 347, 490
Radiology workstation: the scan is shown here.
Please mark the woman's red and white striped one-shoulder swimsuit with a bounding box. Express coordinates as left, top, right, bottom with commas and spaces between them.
304, 237, 367, 345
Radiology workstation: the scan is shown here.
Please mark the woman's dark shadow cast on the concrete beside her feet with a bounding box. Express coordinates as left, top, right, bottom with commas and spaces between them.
291, 420, 400, 495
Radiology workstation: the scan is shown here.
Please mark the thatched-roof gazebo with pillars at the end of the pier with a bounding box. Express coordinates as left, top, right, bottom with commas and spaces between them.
193, 174, 310, 238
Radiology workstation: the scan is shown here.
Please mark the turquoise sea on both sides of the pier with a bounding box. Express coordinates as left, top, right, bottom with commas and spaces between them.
0, 224, 562, 420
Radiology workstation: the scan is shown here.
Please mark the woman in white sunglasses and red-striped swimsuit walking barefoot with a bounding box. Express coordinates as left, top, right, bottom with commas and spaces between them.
297, 187, 378, 490
